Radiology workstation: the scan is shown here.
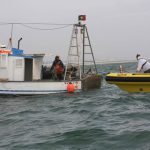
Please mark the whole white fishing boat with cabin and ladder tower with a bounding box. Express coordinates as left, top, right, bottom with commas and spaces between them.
0, 16, 101, 95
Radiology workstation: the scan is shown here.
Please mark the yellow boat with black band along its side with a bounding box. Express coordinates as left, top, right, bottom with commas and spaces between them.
105, 73, 150, 92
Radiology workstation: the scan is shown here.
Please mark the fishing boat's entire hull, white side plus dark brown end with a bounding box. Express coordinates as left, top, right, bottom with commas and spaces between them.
0, 75, 101, 95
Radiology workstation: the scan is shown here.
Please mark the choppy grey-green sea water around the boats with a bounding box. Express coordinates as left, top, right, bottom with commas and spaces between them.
0, 63, 150, 150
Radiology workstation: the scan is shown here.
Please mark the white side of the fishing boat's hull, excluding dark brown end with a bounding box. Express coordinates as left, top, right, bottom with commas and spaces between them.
0, 81, 81, 95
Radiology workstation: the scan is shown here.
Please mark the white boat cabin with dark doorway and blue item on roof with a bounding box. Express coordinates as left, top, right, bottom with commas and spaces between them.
0, 47, 44, 81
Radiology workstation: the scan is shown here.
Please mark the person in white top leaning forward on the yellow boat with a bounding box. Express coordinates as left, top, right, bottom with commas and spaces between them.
136, 54, 150, 73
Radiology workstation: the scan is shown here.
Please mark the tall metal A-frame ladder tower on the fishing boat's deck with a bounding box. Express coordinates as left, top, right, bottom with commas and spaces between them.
64, 22, 97, 80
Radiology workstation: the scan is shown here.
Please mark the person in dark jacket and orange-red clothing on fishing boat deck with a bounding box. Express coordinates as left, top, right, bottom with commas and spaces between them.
50, 56, 65, 80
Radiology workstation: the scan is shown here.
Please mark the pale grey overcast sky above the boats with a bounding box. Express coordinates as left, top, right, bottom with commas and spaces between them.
0, 0, 150, 60
